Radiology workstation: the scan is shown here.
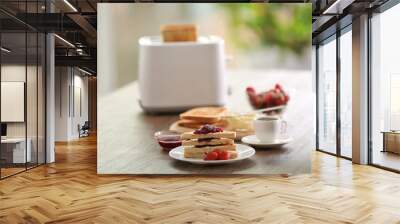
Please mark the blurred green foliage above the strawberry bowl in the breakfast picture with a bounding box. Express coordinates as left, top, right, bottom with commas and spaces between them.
220, 3, 312, 55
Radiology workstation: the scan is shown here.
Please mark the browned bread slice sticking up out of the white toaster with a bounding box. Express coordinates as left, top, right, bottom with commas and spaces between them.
161, 24, 197, 42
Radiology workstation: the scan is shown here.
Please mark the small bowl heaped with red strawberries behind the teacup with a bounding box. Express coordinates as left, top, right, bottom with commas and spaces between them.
246, 83, 290, 114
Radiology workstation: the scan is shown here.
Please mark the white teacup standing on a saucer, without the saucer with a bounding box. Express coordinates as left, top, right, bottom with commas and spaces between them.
253, 117, 287, 142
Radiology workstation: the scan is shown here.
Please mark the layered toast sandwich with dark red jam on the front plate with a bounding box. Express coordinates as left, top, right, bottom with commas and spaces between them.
181, 125, 237, 159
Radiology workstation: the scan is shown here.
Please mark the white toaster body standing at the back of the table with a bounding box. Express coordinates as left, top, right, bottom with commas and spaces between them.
139, 36, 228, 113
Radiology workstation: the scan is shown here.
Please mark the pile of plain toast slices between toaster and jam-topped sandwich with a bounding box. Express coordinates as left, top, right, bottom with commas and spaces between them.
178, 107, 228, 129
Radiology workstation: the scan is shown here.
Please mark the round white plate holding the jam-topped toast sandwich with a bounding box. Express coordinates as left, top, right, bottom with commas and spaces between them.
169, 144, 256, 164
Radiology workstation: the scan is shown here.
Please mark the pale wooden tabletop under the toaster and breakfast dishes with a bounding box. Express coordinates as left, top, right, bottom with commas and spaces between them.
97, 70, 315, 175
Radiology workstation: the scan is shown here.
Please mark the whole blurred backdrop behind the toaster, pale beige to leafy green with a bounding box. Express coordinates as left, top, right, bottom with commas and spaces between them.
98, 3, 312, 86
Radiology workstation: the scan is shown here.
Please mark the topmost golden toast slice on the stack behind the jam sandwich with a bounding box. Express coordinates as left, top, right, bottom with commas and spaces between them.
180, 107, 227, 124
